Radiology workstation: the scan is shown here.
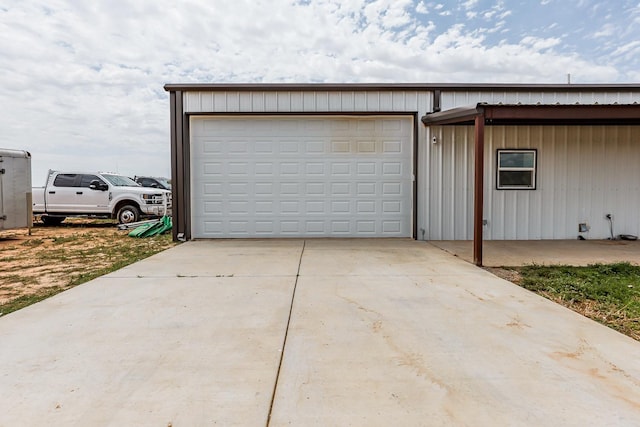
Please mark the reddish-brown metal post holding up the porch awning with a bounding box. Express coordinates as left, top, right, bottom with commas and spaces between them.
473, 111, 485, 267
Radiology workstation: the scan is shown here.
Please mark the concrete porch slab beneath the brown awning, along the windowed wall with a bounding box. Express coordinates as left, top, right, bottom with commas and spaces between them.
429, 239, 640, 267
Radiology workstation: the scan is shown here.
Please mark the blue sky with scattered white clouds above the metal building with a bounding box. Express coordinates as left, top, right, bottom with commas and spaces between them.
0, 0, 640, 185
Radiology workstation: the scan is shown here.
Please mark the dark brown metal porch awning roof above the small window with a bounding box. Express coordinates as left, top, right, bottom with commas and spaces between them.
422, 103, 640, 126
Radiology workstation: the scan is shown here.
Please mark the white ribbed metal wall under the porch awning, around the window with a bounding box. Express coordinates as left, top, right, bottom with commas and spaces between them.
427, 126, 640, 240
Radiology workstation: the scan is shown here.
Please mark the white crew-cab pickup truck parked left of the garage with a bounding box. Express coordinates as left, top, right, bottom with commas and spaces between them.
32, 171, 171, 225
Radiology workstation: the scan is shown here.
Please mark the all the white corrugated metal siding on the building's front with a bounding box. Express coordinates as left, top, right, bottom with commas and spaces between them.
183, 90, 640, 240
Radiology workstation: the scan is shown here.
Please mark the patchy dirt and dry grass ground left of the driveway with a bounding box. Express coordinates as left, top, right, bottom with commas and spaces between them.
0, 219, 175, 311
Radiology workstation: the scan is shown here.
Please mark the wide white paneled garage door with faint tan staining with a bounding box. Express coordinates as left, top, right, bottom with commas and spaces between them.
191, 116, 413, 238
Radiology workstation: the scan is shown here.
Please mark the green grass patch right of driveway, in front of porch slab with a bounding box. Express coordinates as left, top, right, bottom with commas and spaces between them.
514, 263, 640, 340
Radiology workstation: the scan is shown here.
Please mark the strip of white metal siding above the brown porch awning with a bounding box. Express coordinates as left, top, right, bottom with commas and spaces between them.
440, 91, 640, 111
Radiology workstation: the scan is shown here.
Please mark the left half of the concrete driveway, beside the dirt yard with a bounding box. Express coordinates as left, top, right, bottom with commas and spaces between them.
0, 243, 300, 426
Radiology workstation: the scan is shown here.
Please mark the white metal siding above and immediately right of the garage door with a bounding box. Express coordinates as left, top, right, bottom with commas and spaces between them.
184, 90, 432, 239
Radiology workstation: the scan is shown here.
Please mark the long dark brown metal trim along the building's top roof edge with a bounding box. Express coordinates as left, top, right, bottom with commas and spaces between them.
164, 83, 640, 92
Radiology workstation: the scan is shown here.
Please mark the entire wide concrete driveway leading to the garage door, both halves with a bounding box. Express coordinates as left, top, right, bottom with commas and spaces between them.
0, 239, 640, 427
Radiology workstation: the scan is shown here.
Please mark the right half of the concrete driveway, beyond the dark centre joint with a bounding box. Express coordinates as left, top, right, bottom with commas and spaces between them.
271, 241, 640, 426
